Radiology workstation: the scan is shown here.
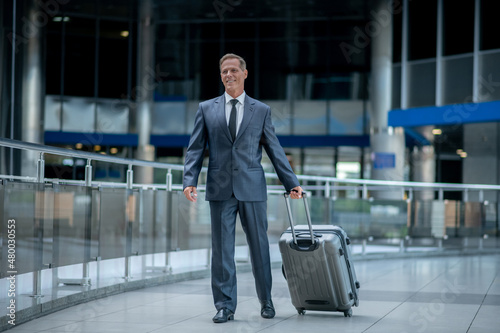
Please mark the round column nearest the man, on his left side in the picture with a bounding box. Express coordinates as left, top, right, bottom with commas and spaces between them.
134, 0, 156, 183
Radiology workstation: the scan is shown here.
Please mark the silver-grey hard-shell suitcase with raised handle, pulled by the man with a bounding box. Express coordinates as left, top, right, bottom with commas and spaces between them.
279, 193, 359, 317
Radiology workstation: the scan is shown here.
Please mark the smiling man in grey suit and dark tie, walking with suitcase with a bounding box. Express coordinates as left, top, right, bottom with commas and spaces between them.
183, 53, 302, 323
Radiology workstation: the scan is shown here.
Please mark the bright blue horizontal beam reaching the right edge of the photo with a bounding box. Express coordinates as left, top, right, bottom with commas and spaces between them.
388, 101, 500, 127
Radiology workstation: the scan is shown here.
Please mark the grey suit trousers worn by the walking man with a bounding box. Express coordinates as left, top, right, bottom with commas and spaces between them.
210, 195, 272, 312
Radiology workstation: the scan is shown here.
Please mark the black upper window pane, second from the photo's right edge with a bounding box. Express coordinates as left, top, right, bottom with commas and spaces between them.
443, 0, 474, 56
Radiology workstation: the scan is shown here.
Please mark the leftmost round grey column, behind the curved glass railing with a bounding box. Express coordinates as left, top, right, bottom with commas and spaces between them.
21, 0, 44, 177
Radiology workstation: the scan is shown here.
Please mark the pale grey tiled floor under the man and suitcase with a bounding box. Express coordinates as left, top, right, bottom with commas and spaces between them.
4, 255, 500, 333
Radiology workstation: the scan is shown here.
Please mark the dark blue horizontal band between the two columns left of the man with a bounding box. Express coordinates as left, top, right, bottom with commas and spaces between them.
44, 131, 138, 147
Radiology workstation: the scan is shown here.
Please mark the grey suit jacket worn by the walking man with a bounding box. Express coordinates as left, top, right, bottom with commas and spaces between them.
183, 95, 299, 201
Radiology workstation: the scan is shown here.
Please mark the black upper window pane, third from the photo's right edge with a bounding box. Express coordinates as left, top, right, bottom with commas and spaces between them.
408, 0, 437, 60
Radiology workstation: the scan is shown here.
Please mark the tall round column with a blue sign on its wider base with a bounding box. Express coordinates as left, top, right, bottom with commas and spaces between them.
370, 0, 405, 200
